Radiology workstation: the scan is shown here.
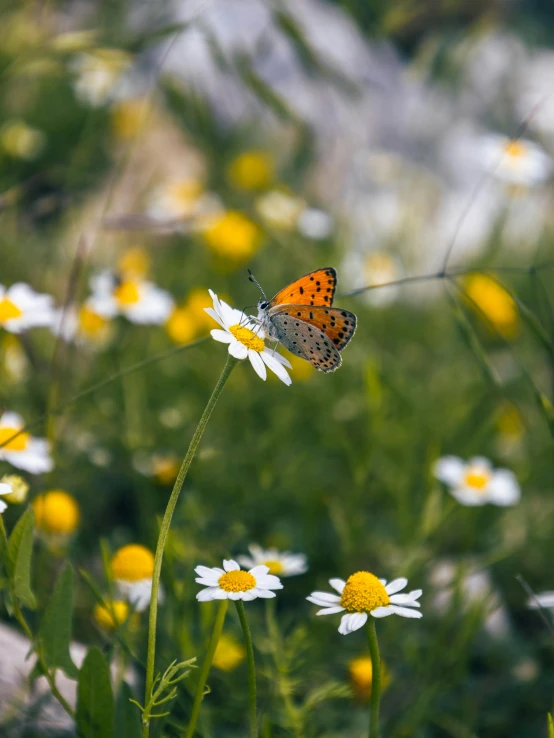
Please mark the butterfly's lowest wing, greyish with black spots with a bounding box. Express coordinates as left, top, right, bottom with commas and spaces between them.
271, 306, 342, 373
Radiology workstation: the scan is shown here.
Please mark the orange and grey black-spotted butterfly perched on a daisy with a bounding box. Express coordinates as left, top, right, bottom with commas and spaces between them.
250, 267, 357, 373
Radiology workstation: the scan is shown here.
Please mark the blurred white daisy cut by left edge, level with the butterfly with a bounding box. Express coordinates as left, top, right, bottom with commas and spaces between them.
0, 282, 54, 333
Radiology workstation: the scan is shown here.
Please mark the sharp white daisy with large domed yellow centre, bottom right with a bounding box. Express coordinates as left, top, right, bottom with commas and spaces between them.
306, 571, 422, 635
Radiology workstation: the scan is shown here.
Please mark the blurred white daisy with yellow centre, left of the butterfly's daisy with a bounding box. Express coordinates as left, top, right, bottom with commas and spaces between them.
87, 271, 173, 325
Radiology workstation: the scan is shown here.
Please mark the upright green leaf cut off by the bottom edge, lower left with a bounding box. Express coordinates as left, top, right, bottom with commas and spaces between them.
75, 648, 115, 738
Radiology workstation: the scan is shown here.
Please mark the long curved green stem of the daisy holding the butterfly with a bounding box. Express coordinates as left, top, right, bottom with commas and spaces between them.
142, 355, 238, 738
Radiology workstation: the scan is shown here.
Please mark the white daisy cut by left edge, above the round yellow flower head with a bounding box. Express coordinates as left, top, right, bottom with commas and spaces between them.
0, 413, 54, 474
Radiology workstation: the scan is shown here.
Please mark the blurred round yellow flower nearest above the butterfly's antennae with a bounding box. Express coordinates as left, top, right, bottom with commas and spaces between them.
204, 210, 262, 262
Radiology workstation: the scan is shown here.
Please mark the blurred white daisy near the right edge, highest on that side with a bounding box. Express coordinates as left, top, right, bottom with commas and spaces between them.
478, 133, 552, 187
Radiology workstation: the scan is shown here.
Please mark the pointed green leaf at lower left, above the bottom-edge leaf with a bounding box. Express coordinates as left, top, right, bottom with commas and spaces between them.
38, 563, 78, 679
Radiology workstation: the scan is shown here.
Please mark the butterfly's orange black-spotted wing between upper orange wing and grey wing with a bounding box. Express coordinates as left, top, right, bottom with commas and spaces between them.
269, 305, 357, 351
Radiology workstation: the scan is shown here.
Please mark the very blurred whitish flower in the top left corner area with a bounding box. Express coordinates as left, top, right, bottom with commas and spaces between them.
71, 49, 131, 107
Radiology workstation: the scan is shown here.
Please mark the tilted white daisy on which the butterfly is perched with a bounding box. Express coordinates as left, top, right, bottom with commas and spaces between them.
205, 290, 291, 385
